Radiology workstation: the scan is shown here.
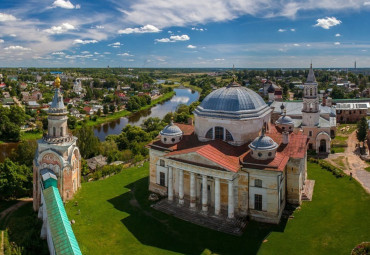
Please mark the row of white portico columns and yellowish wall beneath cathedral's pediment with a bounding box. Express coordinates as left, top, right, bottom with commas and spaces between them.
166, 160, 237, 218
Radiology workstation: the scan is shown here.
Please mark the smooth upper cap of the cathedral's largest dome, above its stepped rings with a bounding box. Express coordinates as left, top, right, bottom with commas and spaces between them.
200, 86, 266, 112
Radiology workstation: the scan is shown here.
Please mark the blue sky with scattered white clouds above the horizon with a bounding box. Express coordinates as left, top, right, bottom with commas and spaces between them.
0, 0, 370, 68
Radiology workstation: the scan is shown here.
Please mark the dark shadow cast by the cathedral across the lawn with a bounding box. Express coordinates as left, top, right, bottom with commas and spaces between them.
108, 177, 287, 254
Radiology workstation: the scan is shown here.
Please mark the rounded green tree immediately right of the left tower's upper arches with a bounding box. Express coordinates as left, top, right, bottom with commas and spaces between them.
76, 124, 99, 158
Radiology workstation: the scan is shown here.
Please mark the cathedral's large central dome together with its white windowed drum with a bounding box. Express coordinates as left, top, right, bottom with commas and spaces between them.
194, 78, 271, 146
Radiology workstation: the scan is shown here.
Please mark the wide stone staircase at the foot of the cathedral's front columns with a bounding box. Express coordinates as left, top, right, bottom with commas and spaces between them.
152, 199, 247, 236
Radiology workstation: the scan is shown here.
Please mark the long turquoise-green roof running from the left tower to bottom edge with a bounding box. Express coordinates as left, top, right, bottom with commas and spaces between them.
43, 186, 82, 255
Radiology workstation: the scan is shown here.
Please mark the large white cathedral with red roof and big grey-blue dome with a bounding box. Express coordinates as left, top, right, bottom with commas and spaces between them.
149, 70, 317, 230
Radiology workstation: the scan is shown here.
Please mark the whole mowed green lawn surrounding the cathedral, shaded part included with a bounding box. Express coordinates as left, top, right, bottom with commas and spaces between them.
66, 163, 370, 254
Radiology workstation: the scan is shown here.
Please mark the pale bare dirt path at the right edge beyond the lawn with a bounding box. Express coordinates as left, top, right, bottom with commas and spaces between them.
327, 131, 370, 193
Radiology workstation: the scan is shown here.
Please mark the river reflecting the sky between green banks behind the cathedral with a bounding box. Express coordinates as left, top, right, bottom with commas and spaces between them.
94, 88, 199, 141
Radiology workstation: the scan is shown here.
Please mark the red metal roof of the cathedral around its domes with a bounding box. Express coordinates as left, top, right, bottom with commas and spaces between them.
148, 124, 308, 172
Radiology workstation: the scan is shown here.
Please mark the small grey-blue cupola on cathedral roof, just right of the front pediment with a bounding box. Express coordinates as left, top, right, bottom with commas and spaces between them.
249, 128, 279, 160
